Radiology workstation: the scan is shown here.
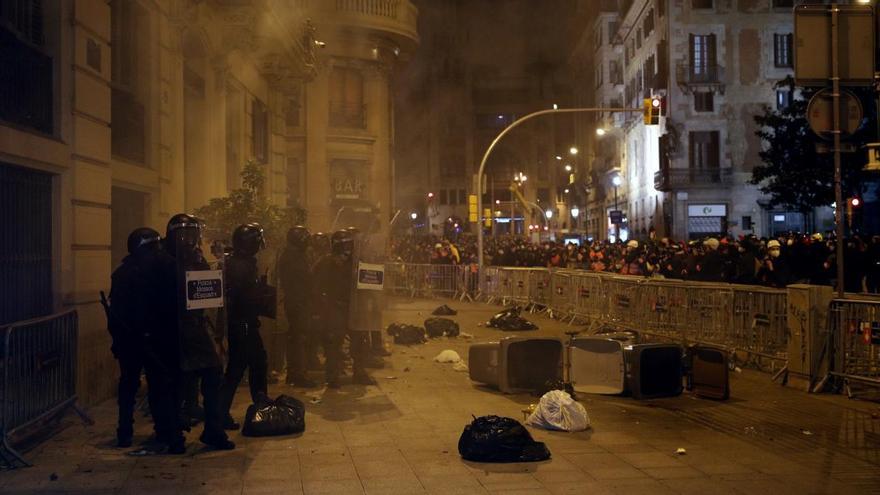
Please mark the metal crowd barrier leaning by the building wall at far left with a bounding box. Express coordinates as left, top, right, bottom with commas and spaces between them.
0, 310, 91, 467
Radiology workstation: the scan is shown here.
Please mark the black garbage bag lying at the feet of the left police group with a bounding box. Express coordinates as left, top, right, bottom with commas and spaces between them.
241, 395, 306, 437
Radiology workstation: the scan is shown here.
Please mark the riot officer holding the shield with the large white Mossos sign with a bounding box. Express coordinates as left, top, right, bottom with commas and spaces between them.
165, 213, 235, 450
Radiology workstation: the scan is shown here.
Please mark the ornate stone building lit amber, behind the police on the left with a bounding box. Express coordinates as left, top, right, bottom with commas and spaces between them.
0, 0, 418, 403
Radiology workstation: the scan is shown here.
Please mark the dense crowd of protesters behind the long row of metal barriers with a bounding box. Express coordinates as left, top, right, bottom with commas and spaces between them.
392, 233, 880, 293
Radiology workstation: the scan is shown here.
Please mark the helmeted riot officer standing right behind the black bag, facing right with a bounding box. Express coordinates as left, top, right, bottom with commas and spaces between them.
222, 223, 268, 429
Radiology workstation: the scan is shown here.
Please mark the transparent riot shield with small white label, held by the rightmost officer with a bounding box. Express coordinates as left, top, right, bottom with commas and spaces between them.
348, 234, 385, 332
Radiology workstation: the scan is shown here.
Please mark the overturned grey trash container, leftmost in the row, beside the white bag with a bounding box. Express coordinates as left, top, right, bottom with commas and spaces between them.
468, 337, 565, 394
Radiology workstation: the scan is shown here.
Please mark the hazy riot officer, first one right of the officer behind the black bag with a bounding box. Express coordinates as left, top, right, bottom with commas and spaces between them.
278, 225, 315, 387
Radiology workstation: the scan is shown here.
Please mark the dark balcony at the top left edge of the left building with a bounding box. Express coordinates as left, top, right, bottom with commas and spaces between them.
0, 28, 54, 134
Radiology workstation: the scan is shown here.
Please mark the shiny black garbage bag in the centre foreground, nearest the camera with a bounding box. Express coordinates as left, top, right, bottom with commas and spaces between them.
458, 416, 550, 462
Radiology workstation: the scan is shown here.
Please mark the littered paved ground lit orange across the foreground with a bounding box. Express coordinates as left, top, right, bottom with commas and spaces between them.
0, 300, 880, 495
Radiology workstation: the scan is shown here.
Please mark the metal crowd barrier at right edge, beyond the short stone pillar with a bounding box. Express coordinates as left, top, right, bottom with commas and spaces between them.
829, 298, 880, 385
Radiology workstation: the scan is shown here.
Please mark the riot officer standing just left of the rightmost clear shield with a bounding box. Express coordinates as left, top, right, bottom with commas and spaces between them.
314, 230, 374, 388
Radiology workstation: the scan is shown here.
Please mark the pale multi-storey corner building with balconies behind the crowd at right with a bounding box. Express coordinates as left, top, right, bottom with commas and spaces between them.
580, 0, 793, 239
